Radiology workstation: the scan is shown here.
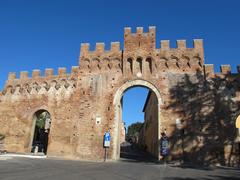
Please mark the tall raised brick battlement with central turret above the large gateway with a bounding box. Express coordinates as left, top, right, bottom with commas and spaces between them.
79, 26, 204, 75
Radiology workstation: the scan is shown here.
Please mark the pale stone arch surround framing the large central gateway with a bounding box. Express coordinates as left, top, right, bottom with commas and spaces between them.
112, 79, 163, 159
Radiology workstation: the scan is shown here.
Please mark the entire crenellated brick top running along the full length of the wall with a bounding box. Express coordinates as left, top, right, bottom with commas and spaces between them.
7, 26, 234, 88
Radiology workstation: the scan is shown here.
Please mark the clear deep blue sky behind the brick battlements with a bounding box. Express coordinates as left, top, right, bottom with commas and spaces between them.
0, 0, 240, 128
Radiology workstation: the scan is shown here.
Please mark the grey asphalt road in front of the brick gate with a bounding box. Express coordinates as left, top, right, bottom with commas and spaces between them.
0, 157, 240, 180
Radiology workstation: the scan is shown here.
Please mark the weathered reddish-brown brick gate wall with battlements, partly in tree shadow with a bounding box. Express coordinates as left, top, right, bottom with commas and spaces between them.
0, 27, 240, 165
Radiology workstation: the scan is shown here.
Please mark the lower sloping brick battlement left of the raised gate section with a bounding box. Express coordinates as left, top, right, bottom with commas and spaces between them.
2, 66, 79, 98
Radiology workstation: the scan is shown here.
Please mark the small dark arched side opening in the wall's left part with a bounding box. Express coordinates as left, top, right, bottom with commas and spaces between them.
31, 110, 52, 154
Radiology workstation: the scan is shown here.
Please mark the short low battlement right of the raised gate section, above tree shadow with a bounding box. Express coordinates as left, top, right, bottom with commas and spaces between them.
204, 64, 240, 77
